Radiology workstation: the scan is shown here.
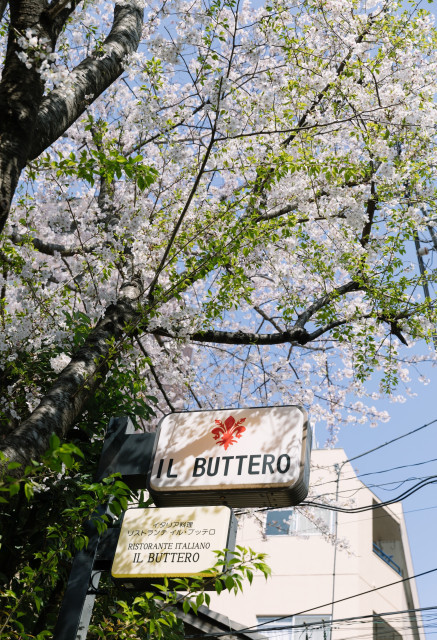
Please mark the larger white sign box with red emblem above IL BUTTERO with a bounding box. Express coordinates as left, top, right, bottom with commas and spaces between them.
148, 405, 311, 507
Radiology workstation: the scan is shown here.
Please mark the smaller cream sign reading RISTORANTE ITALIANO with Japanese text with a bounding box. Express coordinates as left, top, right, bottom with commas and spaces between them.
111, 506, 237, 589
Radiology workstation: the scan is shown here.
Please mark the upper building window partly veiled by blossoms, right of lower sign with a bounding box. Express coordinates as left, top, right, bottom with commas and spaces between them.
266, 507, 334, 536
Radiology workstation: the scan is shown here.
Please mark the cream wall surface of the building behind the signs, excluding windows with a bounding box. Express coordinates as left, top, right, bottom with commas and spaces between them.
211, 449, 423, 640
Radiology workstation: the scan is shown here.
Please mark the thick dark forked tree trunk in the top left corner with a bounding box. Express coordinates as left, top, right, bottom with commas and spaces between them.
0, 0, 143, 233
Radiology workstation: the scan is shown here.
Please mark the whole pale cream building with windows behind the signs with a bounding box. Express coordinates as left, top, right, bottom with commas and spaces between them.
206, 449, 424, 640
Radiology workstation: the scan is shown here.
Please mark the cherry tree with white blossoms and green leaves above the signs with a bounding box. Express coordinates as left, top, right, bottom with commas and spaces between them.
0, 0, 437, 636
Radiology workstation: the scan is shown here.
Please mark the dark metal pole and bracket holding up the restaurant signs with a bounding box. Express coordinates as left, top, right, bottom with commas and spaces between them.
53, 418, 155, 640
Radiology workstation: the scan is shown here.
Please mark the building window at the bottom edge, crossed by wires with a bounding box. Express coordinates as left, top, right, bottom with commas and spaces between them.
257, 616, 330, 640
